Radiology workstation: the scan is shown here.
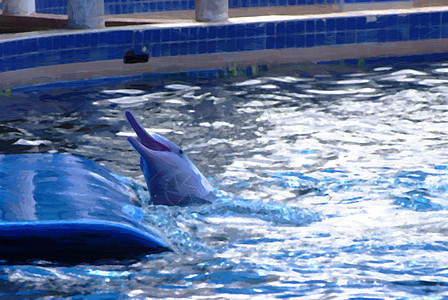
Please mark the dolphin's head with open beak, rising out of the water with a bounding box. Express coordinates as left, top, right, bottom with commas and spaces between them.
126, 111, 214, 205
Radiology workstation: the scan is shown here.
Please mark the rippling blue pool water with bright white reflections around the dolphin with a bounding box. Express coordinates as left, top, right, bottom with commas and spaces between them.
0, 62, 448, 299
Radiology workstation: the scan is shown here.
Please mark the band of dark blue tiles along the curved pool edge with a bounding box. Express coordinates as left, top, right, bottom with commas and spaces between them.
0, 11, 448, 72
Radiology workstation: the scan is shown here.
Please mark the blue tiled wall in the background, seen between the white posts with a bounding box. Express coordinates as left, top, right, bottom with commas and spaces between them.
36, 0, 412, 15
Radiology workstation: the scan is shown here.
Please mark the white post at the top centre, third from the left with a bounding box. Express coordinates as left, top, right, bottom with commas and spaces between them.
194, 0, 229, 22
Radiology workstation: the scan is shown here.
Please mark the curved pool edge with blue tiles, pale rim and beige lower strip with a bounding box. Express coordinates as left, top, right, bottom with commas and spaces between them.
0, 7, 448, 89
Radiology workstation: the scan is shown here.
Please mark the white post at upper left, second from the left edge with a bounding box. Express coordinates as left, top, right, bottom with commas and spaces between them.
67, 0, 104, 28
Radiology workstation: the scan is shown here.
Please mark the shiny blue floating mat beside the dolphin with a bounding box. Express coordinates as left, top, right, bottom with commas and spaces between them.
0, 154, 170, 262
